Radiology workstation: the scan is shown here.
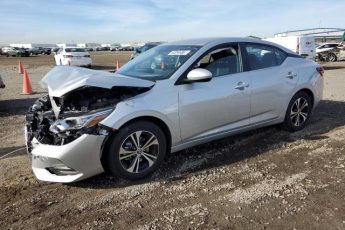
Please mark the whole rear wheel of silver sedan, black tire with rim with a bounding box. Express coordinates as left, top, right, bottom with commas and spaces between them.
284, 91, 313, 132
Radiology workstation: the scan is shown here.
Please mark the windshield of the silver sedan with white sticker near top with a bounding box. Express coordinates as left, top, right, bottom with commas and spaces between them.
117, 45, 200, 80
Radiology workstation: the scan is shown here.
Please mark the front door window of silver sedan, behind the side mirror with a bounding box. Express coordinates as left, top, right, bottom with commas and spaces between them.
195, 45, 242, 77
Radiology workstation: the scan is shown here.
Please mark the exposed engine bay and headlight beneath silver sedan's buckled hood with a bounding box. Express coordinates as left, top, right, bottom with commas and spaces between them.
26, 86, 150, 148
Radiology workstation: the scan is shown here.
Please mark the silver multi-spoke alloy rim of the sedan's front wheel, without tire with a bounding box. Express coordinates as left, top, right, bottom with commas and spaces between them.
119, 130, 159, 173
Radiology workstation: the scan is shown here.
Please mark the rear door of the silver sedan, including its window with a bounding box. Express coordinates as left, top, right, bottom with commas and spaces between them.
243, 43, 298, 124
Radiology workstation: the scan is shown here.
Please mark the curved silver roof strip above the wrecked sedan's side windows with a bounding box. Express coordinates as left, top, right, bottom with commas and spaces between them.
163, 37, 293, 53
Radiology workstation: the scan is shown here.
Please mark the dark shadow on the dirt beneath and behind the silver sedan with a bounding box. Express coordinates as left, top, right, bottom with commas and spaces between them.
68, 100, 345, 189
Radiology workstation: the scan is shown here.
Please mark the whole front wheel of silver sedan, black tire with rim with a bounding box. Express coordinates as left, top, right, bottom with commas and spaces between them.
106, 121, 167, 180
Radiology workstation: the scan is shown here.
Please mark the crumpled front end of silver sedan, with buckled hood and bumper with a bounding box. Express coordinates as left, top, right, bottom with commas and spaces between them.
25, 67, 153, 182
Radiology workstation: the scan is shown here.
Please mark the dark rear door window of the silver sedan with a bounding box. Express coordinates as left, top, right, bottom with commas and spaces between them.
246, 44, 286, 70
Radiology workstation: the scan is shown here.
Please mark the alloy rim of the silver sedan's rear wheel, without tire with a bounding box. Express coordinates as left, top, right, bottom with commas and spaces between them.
290, 97, 309, 127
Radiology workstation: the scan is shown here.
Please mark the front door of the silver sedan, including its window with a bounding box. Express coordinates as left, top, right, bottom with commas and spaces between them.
178, 44, 250, 142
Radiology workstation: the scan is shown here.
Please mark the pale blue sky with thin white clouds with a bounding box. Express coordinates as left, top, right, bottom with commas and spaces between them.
0, 0, 345, 44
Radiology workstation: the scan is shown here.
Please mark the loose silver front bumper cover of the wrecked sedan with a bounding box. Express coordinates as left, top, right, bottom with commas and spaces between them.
30, 134, 106, 183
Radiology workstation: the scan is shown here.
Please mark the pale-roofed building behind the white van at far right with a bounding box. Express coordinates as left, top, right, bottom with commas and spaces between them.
275, 28, 345, 43
